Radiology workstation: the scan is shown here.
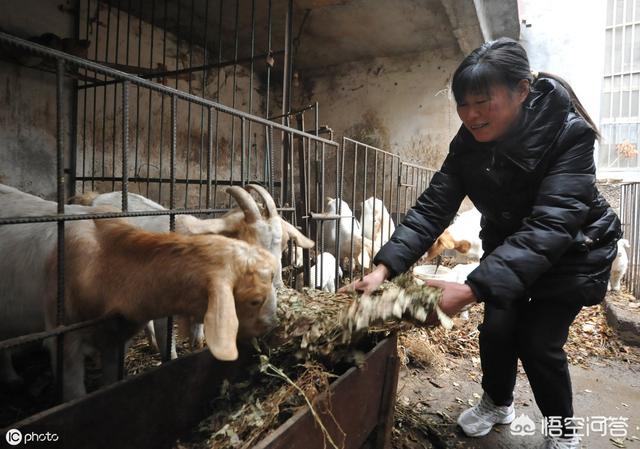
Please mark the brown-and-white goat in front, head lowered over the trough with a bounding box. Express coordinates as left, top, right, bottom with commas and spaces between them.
0, 184, 277, 399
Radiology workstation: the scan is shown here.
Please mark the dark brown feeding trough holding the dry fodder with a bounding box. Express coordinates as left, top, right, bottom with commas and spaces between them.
2, 333, 399, 449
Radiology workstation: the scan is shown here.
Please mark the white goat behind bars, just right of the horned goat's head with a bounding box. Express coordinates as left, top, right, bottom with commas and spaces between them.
314, 198, 373, 267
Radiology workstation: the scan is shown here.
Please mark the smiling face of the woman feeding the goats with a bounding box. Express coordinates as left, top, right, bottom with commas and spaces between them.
458, 80, 529, 142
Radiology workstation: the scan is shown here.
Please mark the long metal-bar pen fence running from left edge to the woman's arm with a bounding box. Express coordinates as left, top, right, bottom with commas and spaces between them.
0, 0, 433, 424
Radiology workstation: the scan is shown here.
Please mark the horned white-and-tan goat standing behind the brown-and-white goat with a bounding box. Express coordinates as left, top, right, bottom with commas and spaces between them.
77, 184, 314, 359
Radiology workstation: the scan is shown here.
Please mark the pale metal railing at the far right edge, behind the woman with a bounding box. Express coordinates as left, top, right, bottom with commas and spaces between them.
620, 182, 640, 300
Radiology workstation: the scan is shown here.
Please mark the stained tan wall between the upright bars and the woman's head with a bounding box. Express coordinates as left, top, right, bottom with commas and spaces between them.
297, 47, 461, 214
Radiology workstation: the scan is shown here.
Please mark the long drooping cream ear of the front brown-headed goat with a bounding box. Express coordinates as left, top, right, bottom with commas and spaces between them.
204, 283, 238, 361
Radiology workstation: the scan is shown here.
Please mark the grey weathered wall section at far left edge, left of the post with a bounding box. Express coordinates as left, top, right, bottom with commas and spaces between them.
0, 0, 73, 199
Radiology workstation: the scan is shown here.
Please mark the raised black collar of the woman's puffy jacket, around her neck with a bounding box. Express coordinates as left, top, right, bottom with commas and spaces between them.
456, 78, 573, 172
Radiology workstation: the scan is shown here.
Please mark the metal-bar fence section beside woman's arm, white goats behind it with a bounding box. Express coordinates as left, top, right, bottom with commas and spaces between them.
305, 137, 434, 288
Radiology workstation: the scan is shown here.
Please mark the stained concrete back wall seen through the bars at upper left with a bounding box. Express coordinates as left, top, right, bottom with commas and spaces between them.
0, 0, 270, 206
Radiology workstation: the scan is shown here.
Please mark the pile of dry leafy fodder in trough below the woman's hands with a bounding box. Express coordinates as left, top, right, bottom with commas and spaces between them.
175, 277, 441, 449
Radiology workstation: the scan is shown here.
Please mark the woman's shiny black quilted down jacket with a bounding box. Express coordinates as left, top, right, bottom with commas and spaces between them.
374, 78, 621, 307
